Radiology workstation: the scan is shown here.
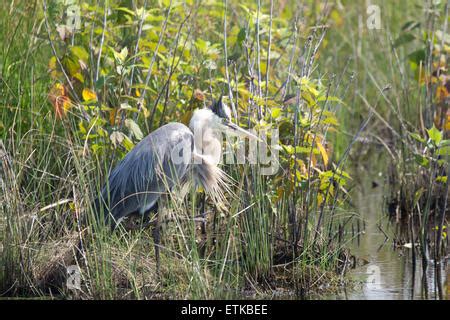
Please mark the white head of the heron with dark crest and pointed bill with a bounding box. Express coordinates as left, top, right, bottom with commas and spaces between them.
189, 97, 258, 139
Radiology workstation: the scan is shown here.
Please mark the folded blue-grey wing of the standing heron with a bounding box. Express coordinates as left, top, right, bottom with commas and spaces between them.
102, 123, 193, 220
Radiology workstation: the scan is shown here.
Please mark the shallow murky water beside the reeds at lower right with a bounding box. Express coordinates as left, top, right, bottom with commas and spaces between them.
327, 174, 450, 300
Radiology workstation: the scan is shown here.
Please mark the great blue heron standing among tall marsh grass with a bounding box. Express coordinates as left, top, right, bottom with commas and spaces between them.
94, 99, 257, 269
